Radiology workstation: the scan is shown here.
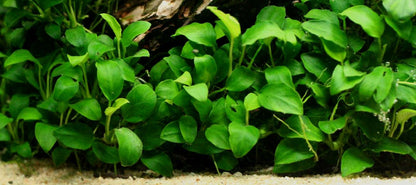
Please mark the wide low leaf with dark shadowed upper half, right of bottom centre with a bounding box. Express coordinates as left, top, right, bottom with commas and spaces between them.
274, 139, 314, 165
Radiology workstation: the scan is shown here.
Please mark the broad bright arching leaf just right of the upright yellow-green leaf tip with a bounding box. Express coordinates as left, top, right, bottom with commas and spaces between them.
241, 22, 286, 46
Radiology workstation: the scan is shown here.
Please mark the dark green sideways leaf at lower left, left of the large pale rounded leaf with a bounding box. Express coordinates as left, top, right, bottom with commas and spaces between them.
53, 123, 94, 150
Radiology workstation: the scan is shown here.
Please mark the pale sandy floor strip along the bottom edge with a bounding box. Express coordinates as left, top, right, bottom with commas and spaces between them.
0, 160, 416, 185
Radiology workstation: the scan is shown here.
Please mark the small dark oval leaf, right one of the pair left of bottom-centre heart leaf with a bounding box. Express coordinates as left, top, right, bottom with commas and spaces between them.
179, 115, 198, 143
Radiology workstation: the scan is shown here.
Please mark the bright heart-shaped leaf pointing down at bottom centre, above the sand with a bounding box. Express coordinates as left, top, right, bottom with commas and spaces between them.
228, 122, 260, 158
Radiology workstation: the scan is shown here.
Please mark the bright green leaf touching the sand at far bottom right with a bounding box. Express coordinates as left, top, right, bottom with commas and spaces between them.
341, 147, 374, 177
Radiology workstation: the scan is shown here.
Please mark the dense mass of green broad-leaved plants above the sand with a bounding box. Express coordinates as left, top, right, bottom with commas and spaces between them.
0, 0, 416, 176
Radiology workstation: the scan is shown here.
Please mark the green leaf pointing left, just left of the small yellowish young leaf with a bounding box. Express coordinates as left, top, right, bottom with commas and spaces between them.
69, 98, 101, 121
